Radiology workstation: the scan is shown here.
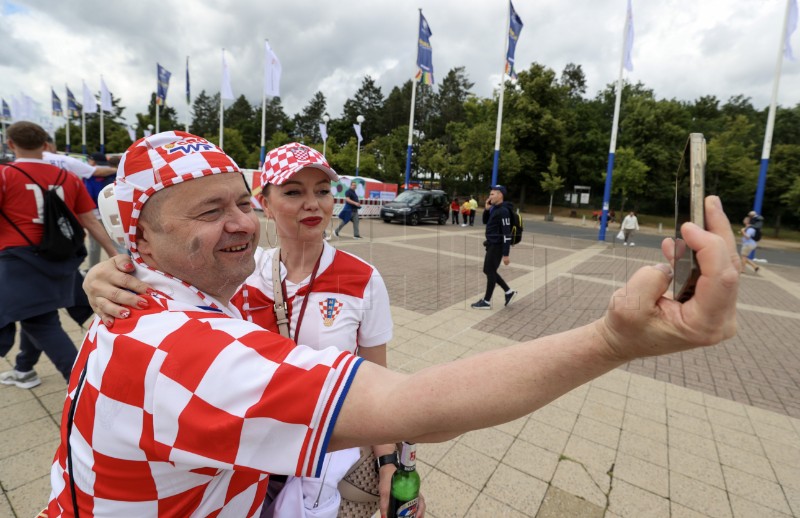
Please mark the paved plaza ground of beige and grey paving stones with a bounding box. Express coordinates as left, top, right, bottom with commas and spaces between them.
0, 215, 800, 518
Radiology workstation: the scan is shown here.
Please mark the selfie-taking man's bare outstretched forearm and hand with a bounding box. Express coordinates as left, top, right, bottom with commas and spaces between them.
329, 196, 739, 450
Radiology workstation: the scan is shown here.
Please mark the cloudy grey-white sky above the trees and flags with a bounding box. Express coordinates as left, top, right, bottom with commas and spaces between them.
0, 0, 800, 131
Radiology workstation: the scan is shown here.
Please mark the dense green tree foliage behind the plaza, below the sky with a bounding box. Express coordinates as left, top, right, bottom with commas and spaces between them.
47, 63, 800, 230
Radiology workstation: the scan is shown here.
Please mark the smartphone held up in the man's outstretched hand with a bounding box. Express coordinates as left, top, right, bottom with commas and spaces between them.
672, 133, 706, 302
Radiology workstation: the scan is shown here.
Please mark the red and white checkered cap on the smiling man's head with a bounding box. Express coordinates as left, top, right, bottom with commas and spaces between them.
114, 131, 241, 256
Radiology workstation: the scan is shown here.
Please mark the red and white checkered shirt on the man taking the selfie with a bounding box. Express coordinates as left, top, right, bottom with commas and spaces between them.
48, 266, 360, 517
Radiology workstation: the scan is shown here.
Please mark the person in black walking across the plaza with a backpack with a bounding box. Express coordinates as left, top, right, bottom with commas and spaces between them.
472, 185, 517, 309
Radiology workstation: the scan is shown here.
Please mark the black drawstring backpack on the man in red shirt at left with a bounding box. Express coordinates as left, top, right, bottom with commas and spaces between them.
3, 164, 86, 261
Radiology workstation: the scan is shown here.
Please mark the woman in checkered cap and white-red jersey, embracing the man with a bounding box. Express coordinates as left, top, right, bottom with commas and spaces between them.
85, 143, 424, 516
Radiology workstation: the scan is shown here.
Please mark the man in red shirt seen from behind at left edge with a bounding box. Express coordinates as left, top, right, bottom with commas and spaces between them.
0, 121, 114, 389
